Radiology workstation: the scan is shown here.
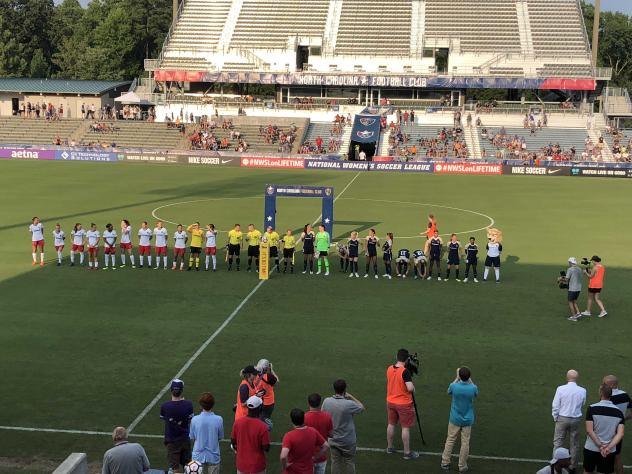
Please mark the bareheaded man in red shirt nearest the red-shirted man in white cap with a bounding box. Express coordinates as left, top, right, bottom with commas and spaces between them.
281, 408, 329, 474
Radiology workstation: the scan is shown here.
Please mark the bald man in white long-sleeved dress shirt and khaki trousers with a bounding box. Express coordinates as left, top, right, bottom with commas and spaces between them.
552, 369, 586, 472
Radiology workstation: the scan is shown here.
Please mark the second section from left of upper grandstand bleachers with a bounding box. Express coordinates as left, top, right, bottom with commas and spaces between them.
230, 0, 329, 49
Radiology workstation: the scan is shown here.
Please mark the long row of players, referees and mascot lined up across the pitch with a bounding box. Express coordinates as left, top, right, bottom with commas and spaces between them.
29, 217, 502, 282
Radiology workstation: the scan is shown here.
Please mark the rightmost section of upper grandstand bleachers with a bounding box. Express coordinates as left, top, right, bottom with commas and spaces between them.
527, 0, 589, 57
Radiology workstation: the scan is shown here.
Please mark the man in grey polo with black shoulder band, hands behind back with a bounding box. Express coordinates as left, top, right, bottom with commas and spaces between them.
584, 385, 624, 474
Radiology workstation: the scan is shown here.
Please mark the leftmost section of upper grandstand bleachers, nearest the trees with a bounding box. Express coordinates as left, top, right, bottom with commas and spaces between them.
165, 0, 232, 57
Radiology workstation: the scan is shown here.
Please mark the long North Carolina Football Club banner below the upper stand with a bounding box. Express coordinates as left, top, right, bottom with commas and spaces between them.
154, 71, 596, 90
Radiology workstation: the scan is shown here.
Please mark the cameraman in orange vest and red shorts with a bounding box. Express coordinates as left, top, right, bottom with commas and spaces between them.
386, 349, 419, 460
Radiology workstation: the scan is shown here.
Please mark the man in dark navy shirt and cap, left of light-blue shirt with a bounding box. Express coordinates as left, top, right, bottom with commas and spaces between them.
160, 382, 193, 472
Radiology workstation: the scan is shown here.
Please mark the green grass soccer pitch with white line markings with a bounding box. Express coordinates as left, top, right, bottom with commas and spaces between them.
0, 160, 632, 473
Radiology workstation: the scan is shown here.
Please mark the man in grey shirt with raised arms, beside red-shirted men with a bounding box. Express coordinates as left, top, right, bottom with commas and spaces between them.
322, 379, 364, 474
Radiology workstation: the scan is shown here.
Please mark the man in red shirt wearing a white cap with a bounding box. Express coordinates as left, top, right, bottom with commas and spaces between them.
230, 395, 270, 474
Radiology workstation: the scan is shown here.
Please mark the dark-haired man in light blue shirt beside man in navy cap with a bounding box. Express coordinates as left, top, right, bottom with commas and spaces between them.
189, 392, 224, 474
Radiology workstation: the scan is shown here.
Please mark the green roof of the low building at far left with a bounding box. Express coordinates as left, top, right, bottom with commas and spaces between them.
0, 77, 131, 95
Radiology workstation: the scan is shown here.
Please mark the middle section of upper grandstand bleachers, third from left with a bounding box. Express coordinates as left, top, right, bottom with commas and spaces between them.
336, 0, 412, 56
